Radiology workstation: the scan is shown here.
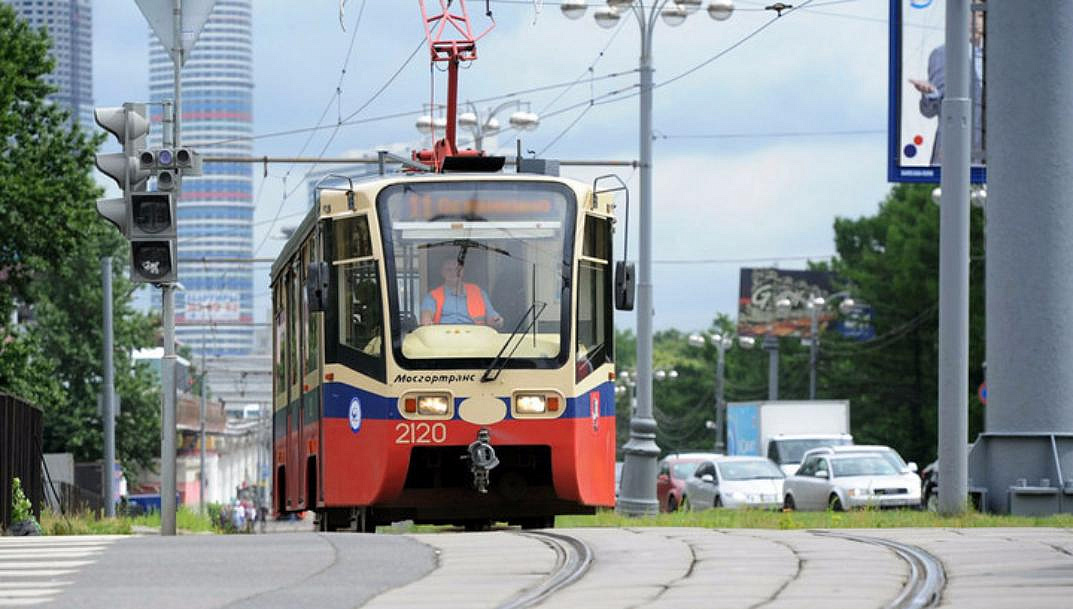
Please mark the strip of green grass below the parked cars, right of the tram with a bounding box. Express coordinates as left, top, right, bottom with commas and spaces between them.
555, 509, 1073, 530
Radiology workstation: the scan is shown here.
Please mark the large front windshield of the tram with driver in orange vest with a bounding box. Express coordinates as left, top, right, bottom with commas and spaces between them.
378, 180, 575, 369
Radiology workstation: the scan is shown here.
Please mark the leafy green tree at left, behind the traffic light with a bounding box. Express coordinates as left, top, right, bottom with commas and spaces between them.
0, 4, 159, 465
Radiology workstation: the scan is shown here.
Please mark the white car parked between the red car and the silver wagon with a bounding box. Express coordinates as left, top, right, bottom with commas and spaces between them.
681, 457, 785, 509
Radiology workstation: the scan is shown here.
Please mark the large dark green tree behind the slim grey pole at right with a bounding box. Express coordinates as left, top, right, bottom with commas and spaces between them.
819, 184, 984, 463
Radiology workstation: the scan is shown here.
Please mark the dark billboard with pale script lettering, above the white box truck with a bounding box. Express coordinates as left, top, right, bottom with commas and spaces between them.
737, 268, 876, 341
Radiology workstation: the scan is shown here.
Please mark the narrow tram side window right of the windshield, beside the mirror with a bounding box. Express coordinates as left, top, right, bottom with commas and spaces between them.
576, 216, 614, 381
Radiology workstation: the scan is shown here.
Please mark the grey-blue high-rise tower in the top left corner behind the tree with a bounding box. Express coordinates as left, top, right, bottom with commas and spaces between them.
5, 0, 95, 129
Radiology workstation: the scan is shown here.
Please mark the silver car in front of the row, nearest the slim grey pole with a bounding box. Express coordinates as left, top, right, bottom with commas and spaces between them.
782, 452, 921, 511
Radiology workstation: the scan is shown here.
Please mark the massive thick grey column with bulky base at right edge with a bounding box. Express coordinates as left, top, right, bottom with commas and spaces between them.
974, 0, 1073, 515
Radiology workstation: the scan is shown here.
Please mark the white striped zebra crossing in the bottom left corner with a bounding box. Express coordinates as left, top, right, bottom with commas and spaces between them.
0, 535, 122, 607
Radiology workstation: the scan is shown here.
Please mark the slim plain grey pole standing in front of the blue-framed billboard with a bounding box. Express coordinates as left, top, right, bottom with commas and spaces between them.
939, 0, 974, 515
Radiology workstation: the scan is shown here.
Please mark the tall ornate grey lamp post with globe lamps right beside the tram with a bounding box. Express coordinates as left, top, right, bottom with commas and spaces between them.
559, 0, 734, 516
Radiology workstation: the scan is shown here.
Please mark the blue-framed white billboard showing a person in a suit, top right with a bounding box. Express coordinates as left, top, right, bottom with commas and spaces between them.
887, 0, 987, 183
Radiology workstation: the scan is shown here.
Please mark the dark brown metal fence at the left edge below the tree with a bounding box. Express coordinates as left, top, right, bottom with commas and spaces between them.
0, 392, 45, 529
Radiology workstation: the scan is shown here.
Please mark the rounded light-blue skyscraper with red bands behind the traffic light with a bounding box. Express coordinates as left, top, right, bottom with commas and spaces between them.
149, 0, 253, 356
